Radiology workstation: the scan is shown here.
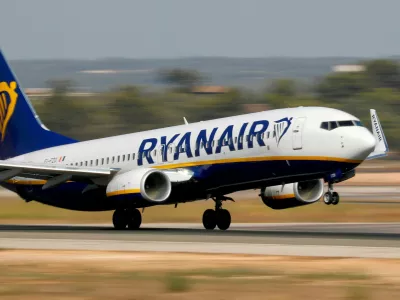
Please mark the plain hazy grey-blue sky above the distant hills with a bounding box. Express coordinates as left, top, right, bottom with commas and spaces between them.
0, 0, 400, 59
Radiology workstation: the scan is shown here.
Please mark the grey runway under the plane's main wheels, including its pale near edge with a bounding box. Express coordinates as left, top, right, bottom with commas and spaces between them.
0, 223, 400, 258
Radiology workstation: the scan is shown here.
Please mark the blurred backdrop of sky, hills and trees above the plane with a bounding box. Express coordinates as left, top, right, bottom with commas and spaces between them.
0, 0, 400, 158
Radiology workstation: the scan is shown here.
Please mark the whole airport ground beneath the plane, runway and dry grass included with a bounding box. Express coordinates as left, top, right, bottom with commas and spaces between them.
0, 167, 400, 300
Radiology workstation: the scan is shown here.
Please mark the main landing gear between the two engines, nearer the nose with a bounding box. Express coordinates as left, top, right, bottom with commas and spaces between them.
203, 196, 233, 230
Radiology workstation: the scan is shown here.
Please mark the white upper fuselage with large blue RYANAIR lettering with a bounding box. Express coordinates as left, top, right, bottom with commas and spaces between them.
11, 107, 373, 171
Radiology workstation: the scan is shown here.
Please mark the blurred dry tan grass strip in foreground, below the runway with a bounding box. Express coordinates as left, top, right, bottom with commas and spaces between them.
0, 250, 400, 300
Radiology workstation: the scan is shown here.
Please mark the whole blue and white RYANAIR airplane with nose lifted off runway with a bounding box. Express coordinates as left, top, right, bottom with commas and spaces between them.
0, 50, 389, 230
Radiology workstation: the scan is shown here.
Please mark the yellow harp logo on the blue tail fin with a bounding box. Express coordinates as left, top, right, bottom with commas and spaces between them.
0, 81, 18, 142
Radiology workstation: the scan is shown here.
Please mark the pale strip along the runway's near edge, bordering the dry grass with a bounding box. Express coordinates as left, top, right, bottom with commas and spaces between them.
0, 238, 400, 258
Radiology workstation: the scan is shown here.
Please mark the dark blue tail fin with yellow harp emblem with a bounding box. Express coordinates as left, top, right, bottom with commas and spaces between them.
0, 49, 76, 159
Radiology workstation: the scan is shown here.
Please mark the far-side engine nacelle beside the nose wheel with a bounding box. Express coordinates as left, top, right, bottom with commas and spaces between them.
261, 179, 324, 209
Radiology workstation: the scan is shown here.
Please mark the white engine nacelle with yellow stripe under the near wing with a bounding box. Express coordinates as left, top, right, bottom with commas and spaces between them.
107, 168, 171, 202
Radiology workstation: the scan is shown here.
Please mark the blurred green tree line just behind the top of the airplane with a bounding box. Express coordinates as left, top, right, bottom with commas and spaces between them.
33, 59, 400, 150
